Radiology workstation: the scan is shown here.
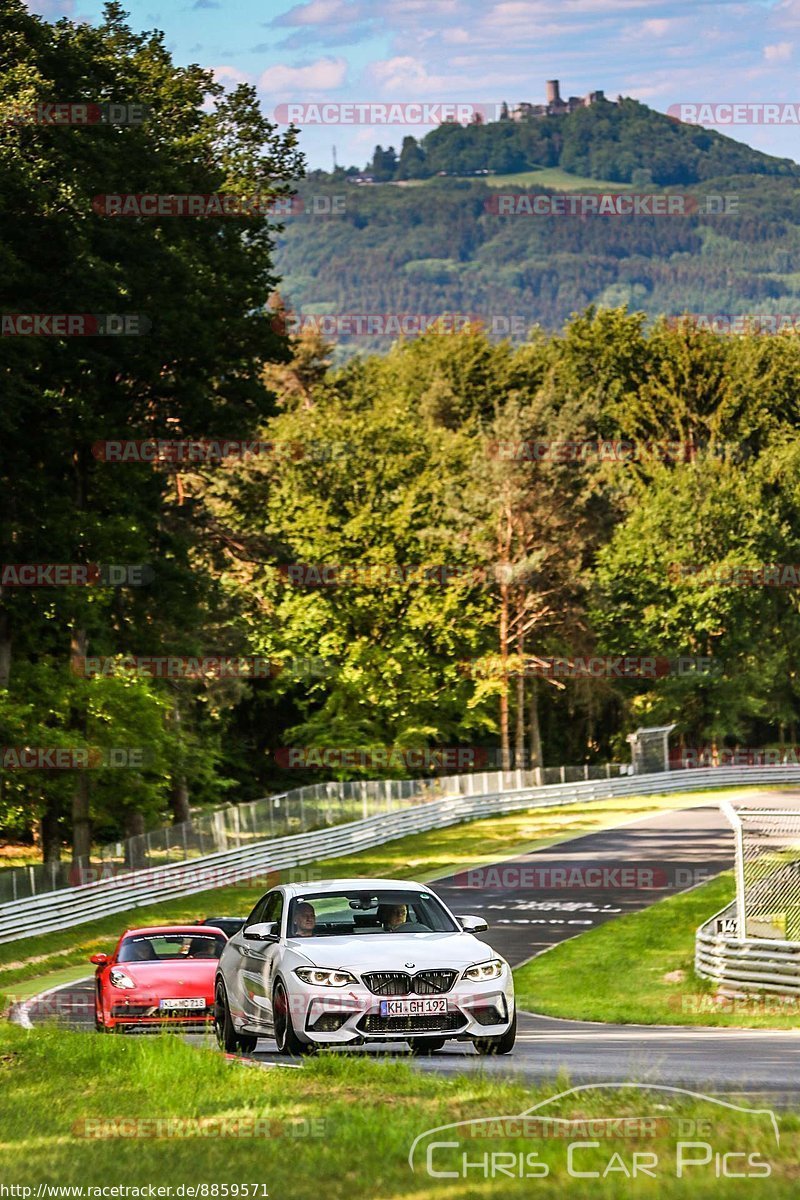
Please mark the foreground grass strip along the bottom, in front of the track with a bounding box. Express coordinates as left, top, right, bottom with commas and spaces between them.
0, 1026, 800, 1200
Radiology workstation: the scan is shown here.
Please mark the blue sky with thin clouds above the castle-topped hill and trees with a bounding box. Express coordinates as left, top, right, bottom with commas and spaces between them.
28, 0, 800, 169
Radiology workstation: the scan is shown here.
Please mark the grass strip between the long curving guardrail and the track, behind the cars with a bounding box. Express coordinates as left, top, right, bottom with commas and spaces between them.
0, 792, 718, 1010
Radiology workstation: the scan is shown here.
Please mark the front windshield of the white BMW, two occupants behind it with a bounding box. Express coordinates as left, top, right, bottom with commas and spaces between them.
288, 888, 458, 937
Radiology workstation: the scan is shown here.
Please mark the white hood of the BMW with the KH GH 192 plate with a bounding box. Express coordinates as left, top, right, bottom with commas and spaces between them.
287, 934, 499, 973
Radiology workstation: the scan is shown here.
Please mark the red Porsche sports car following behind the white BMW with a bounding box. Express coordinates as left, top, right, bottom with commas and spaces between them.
90, 925, 228, 1033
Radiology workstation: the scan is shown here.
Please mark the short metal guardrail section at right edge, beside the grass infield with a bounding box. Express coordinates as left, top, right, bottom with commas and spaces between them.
694, 900, 800, 996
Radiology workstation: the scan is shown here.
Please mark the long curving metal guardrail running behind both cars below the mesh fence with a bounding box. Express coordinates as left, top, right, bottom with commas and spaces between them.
0, 766, 800, 943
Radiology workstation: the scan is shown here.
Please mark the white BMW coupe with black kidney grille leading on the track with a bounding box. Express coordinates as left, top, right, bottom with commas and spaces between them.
215, 880, 517, 1055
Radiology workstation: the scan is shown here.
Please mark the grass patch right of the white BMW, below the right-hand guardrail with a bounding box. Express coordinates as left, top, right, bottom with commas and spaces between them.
515, 871, 800, 1028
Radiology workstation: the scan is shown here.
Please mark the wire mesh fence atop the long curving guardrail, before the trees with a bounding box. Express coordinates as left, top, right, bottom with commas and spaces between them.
0, 763, 628, 904
